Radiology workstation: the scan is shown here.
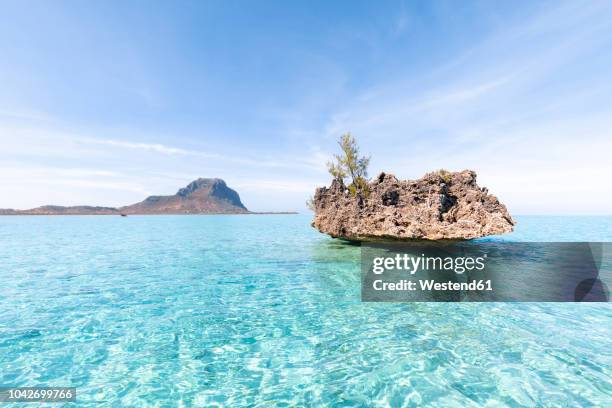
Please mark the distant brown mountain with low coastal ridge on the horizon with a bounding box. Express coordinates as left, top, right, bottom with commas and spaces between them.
0, 178, 250, 215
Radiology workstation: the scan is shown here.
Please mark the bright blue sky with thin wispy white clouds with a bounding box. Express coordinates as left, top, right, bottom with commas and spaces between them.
0, 0, 612, 214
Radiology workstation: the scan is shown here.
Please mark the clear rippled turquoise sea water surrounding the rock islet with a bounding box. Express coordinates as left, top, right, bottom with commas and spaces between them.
0, 215, 612, 407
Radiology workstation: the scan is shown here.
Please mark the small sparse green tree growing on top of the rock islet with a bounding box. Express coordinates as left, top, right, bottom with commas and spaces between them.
327, 133, 370, 198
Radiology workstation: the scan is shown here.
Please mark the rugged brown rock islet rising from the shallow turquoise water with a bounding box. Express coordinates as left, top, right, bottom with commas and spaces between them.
312, 170, 515, 241
